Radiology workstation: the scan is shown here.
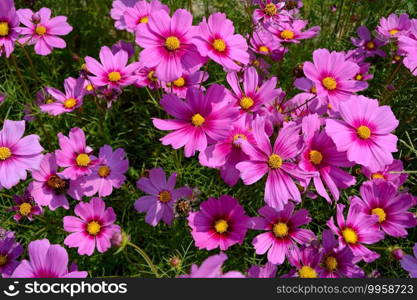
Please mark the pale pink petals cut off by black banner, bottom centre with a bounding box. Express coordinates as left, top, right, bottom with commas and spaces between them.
179, 253, 245, 278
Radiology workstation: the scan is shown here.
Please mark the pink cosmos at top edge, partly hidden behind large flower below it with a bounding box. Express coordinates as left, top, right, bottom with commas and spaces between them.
123, 0, 169, 32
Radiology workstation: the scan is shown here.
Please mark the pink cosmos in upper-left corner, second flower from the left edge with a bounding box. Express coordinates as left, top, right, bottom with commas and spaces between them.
17, 7, 72, 55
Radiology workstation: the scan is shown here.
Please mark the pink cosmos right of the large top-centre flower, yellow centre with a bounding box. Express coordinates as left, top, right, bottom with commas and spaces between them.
193, 13, 249, 71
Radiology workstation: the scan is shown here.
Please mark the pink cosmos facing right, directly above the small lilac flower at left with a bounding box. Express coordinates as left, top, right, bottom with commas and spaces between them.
55, 128, 98, 180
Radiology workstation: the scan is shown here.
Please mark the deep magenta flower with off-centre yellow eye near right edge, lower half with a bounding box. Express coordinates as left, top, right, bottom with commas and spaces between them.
350, 180, 417, 238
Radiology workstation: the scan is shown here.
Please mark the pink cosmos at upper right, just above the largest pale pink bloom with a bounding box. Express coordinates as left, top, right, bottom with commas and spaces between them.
303, 49, 368, 110
